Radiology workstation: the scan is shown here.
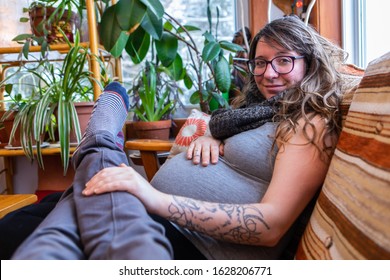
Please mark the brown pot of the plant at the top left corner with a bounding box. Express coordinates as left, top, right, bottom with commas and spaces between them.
29, 7, 80, 44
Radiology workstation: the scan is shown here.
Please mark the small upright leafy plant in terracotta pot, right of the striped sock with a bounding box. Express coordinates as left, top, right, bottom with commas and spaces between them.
129, 61, 182, 140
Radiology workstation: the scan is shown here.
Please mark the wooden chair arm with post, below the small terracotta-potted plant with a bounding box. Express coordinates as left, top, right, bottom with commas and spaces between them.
125, 139, 173, 181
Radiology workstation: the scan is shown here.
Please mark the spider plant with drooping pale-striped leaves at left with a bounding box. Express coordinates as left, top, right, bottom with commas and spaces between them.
3, 33, 105, 174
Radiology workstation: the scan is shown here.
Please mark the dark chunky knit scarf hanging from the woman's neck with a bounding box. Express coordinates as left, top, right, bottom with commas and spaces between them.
209, 94, 282, 139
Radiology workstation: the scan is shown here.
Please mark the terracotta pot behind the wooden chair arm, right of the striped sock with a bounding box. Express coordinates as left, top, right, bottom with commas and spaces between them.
133, 119, 172, 140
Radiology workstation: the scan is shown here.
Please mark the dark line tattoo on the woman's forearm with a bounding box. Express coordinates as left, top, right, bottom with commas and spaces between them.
167, 196, 270, 244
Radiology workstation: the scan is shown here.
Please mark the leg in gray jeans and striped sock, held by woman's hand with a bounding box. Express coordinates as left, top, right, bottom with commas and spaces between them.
73, 83, 172, 259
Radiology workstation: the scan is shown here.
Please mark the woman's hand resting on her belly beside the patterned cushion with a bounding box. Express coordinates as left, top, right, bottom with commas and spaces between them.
187, 136, 224, 166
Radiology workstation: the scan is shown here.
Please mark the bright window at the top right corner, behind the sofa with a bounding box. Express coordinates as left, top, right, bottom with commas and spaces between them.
343, 0, 390, 68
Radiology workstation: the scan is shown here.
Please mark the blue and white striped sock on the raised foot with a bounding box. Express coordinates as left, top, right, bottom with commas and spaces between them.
81, 82, 129, 147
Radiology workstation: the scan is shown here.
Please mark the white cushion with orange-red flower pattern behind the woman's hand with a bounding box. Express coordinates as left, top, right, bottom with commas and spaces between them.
168, 109, 211, 158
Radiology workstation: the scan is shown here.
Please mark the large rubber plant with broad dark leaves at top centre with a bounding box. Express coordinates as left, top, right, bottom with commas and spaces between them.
100, 0, 243, 112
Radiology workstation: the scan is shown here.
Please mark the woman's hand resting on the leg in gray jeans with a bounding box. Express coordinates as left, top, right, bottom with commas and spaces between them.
83, 163, 162, 211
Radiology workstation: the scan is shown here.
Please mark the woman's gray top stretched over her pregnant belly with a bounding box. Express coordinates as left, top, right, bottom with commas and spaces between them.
152, 123, 294, 259
